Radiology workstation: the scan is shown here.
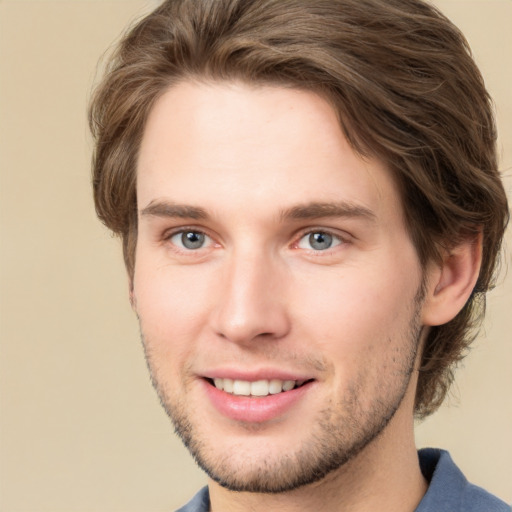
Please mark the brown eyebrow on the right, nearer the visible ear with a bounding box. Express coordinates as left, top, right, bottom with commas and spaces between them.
281, 201, 377, 221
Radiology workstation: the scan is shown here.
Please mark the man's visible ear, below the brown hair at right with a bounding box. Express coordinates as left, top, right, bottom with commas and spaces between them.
422, 232, 482, 326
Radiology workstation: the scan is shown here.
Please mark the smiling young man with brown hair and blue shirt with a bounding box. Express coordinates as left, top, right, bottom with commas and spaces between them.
91, 0, 509, 512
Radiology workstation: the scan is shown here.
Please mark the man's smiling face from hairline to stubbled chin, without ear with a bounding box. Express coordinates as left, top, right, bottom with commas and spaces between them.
133, 83, 422, 492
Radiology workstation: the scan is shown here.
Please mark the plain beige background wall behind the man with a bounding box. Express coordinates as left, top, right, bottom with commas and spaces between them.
0, 0, 512, 512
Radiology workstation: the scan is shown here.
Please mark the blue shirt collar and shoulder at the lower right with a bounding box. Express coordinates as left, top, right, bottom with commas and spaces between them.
416, 448, 511, 512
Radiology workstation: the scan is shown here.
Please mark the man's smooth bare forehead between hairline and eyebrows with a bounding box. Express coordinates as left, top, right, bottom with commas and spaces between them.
137, 82, 401, 222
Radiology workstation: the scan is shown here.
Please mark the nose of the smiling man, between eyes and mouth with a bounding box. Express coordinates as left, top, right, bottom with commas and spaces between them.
212, 249, 290, 344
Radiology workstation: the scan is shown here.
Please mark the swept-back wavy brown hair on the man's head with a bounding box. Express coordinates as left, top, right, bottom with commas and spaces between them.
90, 0, 509, 416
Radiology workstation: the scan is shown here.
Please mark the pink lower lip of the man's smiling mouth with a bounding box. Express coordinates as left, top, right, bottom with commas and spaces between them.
203, 380, 313, 423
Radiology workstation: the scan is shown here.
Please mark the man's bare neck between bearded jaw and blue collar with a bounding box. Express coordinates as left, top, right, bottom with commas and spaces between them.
209, 386, 427, 512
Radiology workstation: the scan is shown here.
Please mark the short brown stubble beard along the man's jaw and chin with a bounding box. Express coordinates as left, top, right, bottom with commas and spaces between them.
139, 290, 422, 493
